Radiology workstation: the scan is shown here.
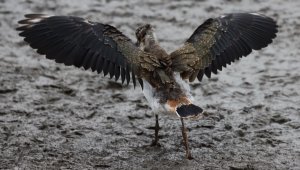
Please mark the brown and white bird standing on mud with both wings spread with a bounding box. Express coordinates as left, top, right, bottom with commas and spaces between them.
16, 12, 278, 159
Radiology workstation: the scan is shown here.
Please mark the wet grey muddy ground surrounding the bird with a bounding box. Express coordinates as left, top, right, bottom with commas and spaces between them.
0, 0, 300, 170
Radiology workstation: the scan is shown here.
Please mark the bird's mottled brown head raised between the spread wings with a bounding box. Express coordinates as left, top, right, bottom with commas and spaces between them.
135, 24, 157, 50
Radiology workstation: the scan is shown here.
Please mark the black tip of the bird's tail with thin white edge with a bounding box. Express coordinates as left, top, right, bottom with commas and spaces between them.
176, 104, 203, 118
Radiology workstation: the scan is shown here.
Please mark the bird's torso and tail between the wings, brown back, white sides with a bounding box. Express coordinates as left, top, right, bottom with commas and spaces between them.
143, 44, 203, 117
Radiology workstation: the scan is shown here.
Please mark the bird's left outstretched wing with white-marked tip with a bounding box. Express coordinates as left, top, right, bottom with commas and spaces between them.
17, 14, 160, 85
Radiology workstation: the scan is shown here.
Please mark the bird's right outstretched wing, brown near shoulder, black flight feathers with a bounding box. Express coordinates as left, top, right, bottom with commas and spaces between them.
171, 13, 277, 81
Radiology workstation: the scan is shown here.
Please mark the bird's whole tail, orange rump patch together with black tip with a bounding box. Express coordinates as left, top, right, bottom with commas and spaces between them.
167, 97, 203, 118
